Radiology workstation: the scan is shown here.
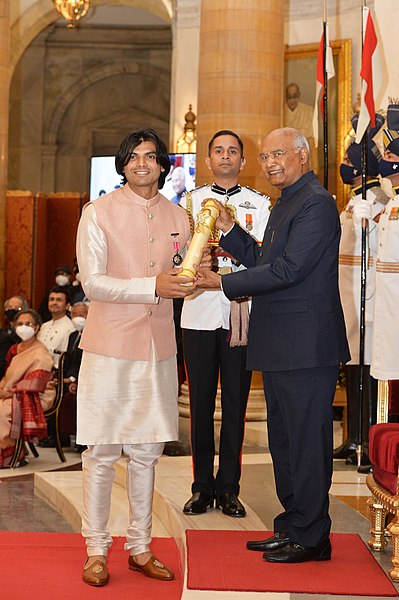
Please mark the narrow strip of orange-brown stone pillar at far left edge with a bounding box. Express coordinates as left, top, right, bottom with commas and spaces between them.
0, 0, 10, 310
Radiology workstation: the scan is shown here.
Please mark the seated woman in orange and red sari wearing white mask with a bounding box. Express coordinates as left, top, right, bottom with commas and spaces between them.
0, 308, 55, 468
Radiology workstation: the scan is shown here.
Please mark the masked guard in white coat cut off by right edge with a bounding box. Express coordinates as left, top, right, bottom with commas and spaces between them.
355, 104, 399, 400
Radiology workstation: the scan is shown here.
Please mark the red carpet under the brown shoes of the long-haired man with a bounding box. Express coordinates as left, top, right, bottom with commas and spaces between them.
0, 531, 183, 600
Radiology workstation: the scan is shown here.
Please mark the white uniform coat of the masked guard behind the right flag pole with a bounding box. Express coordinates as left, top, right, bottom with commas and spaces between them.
339, 180, 388, 365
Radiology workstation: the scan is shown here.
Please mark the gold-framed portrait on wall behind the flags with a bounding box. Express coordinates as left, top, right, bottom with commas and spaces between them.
283, 40, 353, 210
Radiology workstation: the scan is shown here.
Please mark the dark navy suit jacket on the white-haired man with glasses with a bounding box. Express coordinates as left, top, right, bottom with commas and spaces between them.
220, 171, 350, 371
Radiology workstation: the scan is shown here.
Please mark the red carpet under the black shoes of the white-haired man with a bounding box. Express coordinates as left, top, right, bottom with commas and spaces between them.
186, 530, 398, 596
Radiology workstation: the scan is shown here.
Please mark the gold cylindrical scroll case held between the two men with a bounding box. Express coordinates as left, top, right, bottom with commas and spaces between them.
177, 198, 220, 285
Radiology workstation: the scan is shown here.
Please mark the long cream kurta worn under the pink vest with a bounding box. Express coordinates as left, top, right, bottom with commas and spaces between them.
77, 206, 178, 445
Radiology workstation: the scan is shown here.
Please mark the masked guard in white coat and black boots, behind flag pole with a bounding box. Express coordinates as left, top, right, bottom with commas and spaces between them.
333, 114, 388, 466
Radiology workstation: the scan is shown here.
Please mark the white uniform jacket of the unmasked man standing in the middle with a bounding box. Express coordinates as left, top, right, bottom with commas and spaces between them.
180, 183, 270, 331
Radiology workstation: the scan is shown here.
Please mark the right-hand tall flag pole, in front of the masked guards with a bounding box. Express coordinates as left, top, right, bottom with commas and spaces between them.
356, 0, 368, 468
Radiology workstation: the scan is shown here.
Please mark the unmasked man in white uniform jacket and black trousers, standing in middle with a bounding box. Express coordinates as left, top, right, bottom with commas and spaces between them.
181, 130, 270, 517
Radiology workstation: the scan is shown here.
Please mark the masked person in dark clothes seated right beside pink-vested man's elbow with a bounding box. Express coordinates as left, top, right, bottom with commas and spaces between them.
59, 302, 88, 451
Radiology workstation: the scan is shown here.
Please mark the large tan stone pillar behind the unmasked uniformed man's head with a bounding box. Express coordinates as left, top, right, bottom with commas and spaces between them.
196, 0, 285, 195
